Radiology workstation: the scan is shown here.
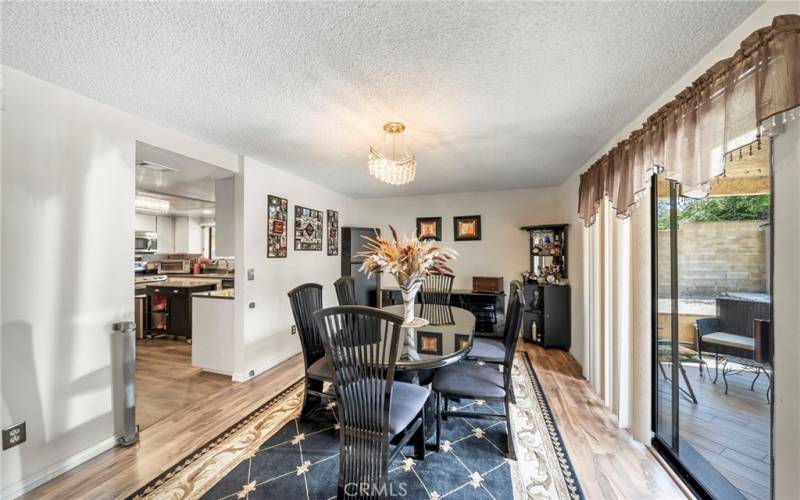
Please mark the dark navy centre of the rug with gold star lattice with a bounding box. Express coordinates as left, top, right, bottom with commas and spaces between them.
203, 400, 514, 500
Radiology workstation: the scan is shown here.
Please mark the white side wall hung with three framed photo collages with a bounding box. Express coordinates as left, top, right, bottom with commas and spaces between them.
234, 158, 352, 380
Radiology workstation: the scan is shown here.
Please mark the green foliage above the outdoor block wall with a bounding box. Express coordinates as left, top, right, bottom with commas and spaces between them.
658, 194, 769, 229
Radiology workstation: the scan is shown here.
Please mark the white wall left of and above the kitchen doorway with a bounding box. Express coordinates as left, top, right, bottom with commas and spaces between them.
0, 67, 237, 496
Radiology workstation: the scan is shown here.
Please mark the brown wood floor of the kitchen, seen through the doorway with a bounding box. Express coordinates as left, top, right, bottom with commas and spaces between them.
136, 339, 234, 430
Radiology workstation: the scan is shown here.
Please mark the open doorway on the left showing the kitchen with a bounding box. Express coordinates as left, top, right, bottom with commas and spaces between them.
134, 142, 235, 429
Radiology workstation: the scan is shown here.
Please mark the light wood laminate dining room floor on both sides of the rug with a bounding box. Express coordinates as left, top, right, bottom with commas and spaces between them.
27, 345, 685, 499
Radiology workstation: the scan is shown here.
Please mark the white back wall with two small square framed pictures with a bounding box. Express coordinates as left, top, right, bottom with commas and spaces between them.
352, 187, 583, 362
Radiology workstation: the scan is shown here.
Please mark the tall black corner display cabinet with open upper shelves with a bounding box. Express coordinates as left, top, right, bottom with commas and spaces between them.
520, 224, 572, 350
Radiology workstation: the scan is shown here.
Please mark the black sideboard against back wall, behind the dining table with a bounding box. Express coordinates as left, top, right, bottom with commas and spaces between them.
381, 287, 506, 337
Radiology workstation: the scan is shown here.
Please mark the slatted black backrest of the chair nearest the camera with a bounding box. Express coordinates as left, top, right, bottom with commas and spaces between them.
314, 306, 403, 491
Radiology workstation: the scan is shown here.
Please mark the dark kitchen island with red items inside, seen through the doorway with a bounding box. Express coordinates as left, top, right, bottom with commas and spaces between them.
145, 281, 217, 342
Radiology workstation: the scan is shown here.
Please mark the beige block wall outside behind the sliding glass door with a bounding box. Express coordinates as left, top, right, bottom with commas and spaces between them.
658, 221, 767, 298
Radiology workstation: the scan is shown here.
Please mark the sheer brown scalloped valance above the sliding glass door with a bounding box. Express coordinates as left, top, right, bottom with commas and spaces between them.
578, 14, 800, 226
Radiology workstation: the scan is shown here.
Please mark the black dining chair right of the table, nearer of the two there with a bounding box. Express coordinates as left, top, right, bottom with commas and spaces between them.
433, 290, 525, 460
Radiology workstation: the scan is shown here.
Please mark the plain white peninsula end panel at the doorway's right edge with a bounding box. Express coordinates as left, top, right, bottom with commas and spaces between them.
192, 288, 235, 375
